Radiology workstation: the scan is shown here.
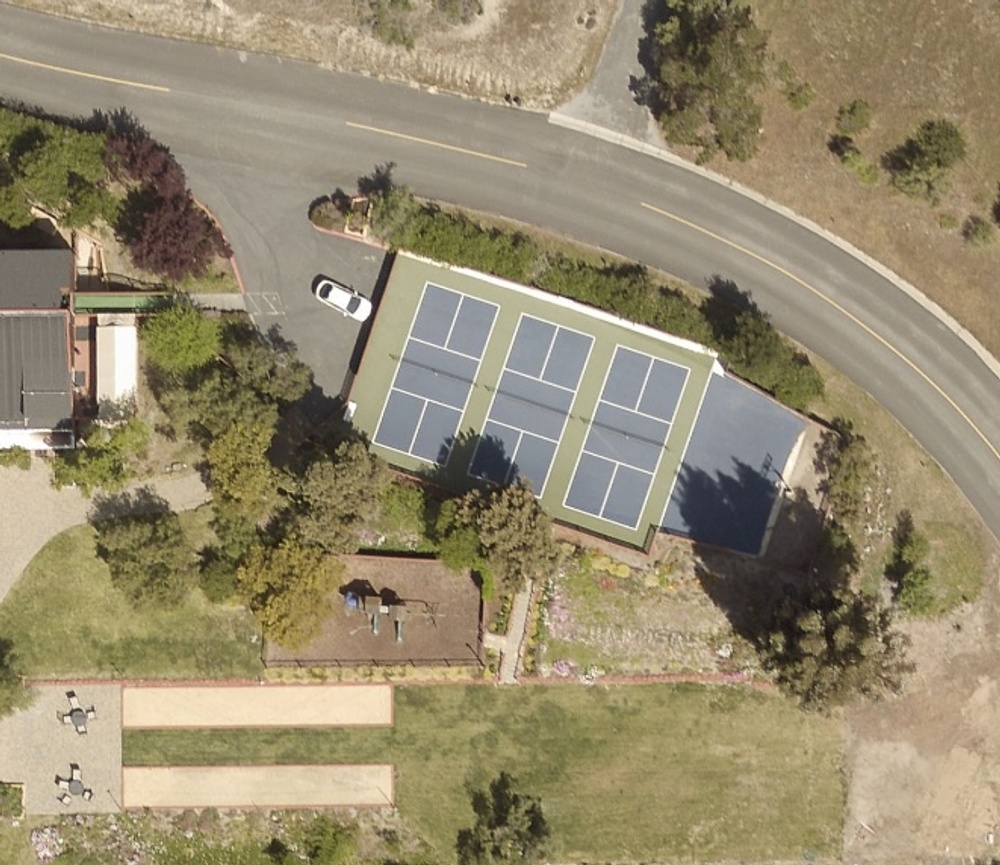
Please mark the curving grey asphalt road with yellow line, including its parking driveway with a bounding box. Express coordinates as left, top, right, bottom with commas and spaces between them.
0, 6, 1000, 537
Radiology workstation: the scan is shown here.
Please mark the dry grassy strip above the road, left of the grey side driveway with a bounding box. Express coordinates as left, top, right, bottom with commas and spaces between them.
17, 0, 618, 108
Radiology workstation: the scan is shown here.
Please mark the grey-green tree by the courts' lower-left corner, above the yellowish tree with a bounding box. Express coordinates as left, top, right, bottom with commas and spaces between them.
292, 440, 392, 553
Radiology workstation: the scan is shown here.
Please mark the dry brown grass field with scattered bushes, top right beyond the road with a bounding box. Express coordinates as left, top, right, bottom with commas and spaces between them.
711, 0, 1000, 354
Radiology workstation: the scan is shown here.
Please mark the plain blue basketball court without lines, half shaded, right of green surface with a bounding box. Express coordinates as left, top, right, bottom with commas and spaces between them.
662, 376, 806, 555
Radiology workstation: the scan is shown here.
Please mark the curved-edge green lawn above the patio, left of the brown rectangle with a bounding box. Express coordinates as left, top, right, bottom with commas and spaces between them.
0, 512, 262, 678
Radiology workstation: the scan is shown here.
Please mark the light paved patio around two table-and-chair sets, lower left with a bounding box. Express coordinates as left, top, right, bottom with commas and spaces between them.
0, 684, 122, 814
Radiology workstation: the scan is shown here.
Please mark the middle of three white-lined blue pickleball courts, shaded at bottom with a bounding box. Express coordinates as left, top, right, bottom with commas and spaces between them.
469, 315, 594, 494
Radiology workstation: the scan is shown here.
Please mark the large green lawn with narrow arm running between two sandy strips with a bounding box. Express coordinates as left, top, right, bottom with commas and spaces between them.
123, 685, 844, 861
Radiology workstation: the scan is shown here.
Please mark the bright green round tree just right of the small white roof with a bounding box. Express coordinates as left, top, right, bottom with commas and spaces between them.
142, 298, 222, 375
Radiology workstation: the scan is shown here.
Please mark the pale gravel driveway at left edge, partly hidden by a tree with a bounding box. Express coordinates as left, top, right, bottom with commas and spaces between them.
0, 458, 208, 602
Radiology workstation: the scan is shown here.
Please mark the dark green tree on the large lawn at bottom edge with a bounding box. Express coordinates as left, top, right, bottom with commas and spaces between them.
455, 772, 550, 865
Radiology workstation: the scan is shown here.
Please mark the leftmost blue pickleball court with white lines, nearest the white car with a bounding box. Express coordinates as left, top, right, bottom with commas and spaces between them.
373, 284, 497, 464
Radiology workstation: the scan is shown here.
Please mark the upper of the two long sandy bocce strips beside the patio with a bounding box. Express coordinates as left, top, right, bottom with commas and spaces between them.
122, 684, 392, 729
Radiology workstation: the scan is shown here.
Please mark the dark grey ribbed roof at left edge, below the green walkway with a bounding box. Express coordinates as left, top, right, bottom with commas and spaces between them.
0, 312, 73, 429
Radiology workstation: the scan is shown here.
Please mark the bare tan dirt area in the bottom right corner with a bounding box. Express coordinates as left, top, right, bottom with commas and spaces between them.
844, 562, 1000, 862
